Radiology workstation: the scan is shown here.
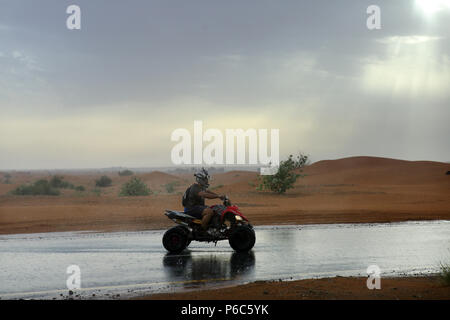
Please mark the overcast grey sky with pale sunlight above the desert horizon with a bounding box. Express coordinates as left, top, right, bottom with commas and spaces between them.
0, 0, 450, 169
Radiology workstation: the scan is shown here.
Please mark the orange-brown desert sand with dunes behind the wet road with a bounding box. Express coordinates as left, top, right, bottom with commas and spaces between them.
0, 157, 450, 234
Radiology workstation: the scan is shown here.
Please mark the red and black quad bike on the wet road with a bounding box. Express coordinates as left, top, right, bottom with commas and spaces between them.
162, 197, 256, 253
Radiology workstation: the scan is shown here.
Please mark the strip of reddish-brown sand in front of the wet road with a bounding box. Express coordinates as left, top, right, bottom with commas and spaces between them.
140, 277, 450, 300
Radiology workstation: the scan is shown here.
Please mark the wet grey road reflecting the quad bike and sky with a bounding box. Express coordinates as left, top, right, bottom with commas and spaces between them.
0, 221, 450, 299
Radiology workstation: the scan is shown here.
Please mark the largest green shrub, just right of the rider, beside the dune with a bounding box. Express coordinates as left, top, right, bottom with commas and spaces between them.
257, 154, 308, 194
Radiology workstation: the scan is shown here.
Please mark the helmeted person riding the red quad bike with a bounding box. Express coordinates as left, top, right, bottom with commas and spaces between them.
183, 168, 225, 231
